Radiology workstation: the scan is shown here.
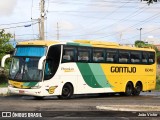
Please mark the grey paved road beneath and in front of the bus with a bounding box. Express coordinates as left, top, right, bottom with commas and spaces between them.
0, 92, 160, 120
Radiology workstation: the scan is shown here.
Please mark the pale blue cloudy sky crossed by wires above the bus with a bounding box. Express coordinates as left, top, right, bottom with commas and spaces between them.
0, 0, 160, 44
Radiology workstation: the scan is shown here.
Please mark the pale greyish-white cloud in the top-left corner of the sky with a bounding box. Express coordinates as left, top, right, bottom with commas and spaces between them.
0, 0, 17, 16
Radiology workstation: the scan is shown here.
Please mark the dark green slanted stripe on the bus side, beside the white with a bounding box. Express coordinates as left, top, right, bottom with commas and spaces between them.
77, 63, 102, 88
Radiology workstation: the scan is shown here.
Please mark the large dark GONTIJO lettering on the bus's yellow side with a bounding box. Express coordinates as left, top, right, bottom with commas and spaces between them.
111, 66, 136, 73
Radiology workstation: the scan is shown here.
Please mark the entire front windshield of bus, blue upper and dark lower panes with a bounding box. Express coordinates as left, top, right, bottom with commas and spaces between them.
9, 46, 46, 81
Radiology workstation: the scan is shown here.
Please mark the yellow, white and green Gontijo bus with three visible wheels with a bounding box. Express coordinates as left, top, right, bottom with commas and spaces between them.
2, 40, 156, 99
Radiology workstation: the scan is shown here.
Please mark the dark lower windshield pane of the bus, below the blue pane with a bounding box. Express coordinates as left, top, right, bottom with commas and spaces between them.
9, 57, 42, 81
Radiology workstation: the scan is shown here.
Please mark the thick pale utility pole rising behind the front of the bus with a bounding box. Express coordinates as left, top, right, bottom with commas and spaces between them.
39, 0, 45, 40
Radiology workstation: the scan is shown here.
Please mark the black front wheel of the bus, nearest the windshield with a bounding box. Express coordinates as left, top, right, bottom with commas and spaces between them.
57, 83, 73, 99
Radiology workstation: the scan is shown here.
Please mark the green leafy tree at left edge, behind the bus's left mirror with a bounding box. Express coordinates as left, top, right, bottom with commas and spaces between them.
0, 30, 13, 61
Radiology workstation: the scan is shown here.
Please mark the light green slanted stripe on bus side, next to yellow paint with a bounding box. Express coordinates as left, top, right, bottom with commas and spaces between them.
89, 63, 111, 88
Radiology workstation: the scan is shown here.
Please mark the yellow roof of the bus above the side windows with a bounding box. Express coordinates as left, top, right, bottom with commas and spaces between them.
17, 40, 155, 51
